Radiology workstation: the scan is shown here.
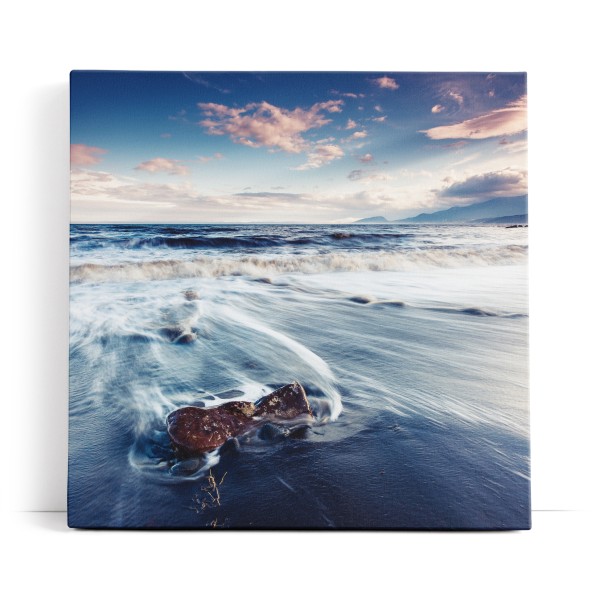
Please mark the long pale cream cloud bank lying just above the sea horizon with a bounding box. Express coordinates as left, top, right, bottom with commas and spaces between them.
71, 169, 422, 223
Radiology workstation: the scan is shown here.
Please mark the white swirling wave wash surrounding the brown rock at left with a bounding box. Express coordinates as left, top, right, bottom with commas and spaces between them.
70, 288, 342, 483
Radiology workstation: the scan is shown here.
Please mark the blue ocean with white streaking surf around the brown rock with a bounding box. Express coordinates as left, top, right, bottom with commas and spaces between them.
68, 224, 530, 529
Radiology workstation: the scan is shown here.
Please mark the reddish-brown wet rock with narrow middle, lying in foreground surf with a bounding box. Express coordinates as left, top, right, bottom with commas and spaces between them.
167, 381, 312, 455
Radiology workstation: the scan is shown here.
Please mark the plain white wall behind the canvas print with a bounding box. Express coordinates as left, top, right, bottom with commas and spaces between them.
0, 0, 600, 597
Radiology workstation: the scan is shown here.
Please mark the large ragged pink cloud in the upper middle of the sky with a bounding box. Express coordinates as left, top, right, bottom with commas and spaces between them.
198, 100, 343, 154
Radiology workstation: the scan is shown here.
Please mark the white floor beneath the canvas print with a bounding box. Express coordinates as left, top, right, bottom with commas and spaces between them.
0, 511, 599, 600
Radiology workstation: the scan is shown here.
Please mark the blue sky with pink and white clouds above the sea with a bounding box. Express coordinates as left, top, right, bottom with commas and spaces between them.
71, 71, 527, 223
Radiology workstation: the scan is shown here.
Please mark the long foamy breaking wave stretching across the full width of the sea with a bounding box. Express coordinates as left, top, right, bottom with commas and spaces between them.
70, 245, 527, 283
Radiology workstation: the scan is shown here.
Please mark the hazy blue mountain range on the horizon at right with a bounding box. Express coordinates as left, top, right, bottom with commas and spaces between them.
355, 195, 527, 223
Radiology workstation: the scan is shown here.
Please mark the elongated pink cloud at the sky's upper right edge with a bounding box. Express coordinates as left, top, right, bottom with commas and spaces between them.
421, 96, 527, 140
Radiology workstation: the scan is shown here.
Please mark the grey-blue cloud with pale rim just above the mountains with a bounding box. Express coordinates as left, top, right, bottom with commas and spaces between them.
438, 169, 527, 199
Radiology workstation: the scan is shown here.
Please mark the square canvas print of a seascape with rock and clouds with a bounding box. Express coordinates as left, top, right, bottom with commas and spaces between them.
68, 71, 530, 530
